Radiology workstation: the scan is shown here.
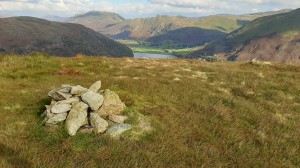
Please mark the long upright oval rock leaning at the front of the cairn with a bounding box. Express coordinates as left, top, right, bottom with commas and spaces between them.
65, 102, 88, 136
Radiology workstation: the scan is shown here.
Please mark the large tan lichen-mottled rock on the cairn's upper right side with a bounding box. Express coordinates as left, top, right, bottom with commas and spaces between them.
97, 89, 126, 116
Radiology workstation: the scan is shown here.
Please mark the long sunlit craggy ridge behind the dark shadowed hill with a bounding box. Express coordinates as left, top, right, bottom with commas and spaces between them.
101, 15, 254, 40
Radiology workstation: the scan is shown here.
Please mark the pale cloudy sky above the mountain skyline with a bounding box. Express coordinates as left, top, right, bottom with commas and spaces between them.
0, 0, 300, 19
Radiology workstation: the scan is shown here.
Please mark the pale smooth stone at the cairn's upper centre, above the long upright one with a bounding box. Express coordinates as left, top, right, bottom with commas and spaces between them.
81, 91, 104, 111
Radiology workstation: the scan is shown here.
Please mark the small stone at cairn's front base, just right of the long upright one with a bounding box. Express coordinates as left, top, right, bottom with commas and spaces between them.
90, 113, 108, 134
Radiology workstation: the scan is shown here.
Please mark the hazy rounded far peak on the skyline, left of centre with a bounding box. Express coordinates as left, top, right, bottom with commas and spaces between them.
66, 11, 125, 32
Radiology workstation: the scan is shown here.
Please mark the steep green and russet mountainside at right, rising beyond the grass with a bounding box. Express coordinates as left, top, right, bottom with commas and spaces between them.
190, 9, 300, 63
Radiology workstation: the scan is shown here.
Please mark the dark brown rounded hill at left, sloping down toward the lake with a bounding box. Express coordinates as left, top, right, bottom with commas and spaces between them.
0, 17, 133, 57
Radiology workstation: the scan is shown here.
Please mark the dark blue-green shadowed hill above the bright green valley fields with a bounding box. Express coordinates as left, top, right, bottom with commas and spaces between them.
147, 27, 227, 48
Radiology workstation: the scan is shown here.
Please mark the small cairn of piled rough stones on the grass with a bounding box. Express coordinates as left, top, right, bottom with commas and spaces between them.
43, 81, 132, 137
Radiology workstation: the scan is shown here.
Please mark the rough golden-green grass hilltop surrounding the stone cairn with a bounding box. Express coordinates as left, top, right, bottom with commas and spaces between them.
0, 54, 300, 168
